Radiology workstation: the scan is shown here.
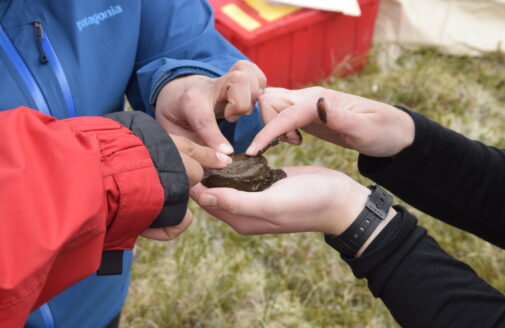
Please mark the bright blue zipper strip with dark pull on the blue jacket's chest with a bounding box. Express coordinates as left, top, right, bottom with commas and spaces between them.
33, 22, 77, 117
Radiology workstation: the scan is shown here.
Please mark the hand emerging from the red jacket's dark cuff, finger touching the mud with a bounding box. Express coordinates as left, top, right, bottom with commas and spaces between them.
141, 135, 232, 241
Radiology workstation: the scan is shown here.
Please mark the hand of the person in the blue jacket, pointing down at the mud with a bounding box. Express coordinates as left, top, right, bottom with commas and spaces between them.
156, 60, 266, 154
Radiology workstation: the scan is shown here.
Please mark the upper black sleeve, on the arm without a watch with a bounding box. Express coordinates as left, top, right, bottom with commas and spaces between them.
358, 111, 505, 248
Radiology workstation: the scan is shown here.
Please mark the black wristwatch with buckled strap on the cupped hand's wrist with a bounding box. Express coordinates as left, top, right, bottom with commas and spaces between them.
324, 185, 393, 257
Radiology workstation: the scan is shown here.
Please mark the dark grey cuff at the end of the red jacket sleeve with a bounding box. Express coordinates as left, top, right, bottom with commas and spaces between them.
104, 111, 189, 228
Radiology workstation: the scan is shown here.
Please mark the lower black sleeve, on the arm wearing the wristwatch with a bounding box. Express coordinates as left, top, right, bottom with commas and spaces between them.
344, 206, 505, 328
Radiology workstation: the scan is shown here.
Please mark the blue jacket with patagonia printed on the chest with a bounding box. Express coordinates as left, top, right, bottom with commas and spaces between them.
0, 0, 261, 327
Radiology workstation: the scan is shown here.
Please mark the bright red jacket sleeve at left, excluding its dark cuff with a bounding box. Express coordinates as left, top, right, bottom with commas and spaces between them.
0, 108, 164, 327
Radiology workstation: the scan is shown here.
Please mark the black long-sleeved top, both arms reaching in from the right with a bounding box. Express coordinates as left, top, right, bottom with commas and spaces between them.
338, 112, 505, 327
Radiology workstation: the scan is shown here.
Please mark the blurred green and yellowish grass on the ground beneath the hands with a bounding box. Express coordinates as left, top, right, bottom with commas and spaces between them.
122, 49, 505, 328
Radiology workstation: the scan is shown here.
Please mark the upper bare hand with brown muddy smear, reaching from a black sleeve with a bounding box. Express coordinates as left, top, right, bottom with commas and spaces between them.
246, 87, 415, 157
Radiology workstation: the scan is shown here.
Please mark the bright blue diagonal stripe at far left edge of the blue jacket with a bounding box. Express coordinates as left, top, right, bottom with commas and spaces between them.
0, 24, 51, 115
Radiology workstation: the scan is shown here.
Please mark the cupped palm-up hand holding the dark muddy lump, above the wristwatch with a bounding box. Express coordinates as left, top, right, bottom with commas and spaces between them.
191, 166, 370, 235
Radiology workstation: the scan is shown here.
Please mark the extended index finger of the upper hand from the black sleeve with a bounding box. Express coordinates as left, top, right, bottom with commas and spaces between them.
246, 101, 318, 156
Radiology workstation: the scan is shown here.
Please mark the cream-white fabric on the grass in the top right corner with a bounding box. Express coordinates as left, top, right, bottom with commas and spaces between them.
374, 0, 505, 55
